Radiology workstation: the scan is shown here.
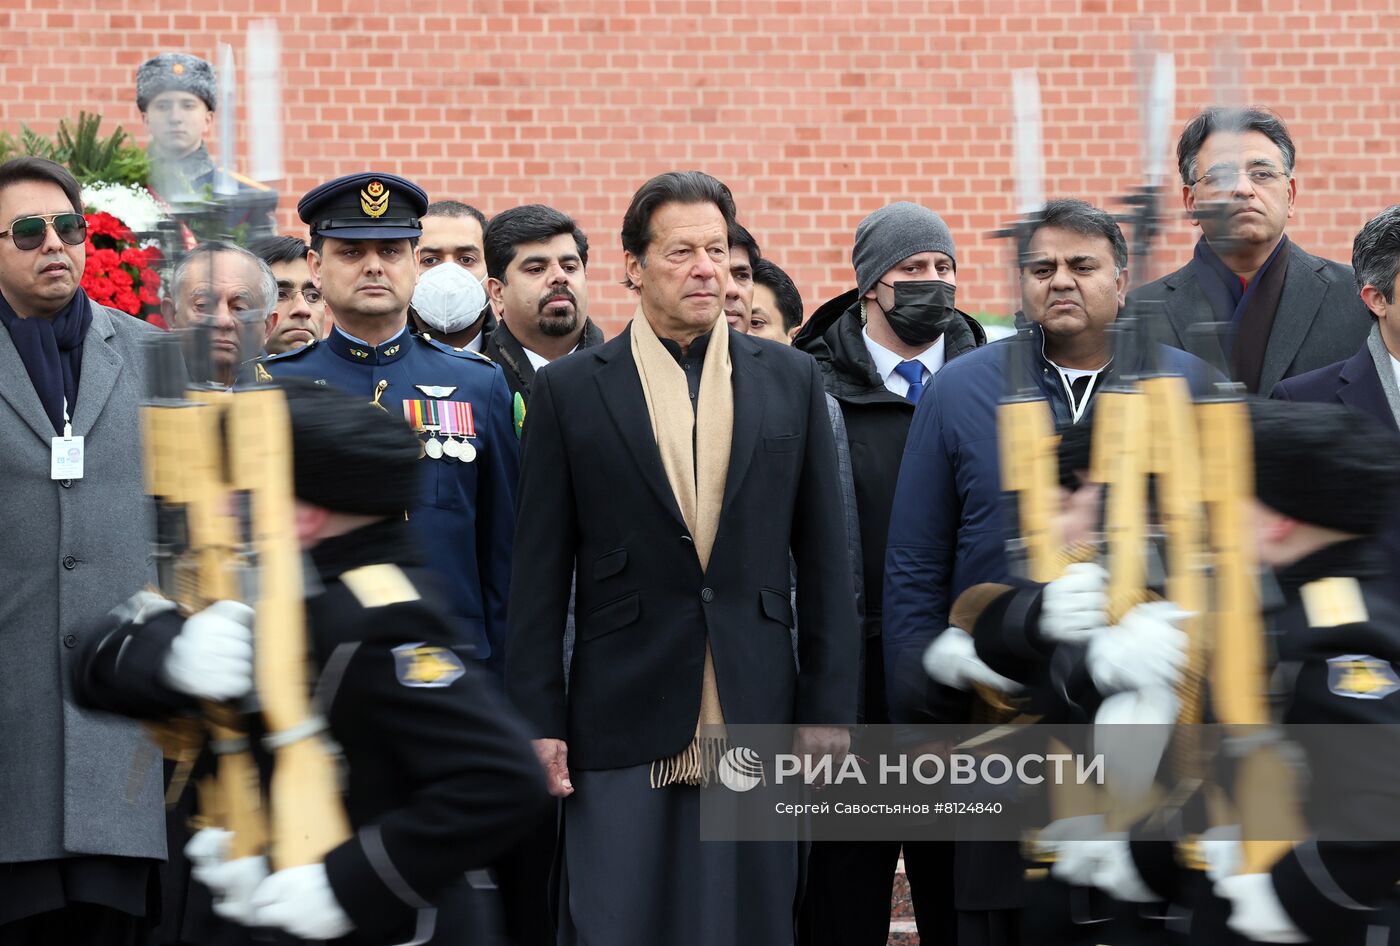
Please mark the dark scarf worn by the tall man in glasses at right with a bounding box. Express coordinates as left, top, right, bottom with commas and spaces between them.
1191, 235, 1288, 393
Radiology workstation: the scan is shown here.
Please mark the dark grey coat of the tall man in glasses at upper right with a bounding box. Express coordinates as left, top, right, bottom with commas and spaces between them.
1128, 242, 1371, 392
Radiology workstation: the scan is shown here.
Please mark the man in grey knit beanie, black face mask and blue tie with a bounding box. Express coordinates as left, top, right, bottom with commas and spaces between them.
795, 202, 987, 946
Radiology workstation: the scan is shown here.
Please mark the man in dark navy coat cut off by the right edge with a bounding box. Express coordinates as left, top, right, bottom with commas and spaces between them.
1270, 204, 1400, 595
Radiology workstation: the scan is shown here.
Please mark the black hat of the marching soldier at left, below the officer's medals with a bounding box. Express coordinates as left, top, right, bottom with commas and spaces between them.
277, 378, 419, 516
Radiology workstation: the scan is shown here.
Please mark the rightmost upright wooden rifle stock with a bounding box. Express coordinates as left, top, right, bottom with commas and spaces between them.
1198, 400, 1306, 873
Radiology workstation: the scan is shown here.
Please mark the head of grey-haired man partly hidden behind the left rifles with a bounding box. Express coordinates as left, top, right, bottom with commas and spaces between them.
161, 241, 277, 388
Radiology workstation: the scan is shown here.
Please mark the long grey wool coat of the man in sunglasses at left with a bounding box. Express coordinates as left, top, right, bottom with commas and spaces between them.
0, 304, 165, 863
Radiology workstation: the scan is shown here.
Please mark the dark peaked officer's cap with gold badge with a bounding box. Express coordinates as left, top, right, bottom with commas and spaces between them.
297, 172, 428, 245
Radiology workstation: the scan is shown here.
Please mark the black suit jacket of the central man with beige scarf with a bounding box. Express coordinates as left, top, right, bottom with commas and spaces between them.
505, 327, 860, 770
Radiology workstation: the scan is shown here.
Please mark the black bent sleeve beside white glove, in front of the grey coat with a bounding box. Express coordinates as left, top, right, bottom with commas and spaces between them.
74, 598, 196, 719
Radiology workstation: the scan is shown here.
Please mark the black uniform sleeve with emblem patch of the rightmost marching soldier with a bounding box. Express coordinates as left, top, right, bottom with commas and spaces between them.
1271, 643, 1400, 942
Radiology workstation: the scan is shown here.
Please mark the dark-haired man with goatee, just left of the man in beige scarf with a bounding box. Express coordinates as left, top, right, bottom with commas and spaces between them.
483, 204, 603, 407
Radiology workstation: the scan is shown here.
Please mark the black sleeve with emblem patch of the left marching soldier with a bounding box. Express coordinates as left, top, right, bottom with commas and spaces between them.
323, 603, 549, 942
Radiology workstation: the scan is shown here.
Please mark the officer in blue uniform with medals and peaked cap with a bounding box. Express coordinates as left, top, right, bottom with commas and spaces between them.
255, 174, 519, 672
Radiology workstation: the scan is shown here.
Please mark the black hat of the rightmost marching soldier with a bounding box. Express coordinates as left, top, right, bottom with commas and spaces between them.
1249, 400, 1400, 536
